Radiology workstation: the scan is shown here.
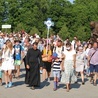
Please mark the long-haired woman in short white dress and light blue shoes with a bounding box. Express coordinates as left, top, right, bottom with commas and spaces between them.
2, 41, 14, 88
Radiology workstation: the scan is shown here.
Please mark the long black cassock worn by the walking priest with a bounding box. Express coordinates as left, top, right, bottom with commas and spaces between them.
26, 48, 42, 86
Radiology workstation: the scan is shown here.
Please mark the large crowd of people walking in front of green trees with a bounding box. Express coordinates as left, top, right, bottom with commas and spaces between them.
0, 31, 98, 92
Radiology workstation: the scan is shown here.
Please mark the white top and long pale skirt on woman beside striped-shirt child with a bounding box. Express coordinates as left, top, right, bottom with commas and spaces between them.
61, 50, 77, 84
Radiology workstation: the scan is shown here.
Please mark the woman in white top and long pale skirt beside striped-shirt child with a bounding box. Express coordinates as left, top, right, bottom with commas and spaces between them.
61, 43, 77, 92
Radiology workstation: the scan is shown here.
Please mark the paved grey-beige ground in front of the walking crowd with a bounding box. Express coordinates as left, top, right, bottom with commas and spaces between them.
0, 63, 98, 98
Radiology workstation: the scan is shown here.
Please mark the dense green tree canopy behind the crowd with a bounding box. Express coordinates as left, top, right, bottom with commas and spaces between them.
0, 0, 98, 40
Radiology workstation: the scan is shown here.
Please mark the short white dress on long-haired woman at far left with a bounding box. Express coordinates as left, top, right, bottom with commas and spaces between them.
2, 48, 14, 71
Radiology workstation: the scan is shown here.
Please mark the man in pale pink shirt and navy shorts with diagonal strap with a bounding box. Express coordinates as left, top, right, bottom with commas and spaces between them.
88, 42, 98, 86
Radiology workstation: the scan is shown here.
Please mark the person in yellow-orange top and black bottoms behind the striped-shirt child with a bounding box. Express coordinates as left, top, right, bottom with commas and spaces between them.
42, 45, 52, 81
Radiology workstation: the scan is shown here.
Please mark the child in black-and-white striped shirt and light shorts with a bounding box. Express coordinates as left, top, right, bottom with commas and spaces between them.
52, 53, 61, 91
